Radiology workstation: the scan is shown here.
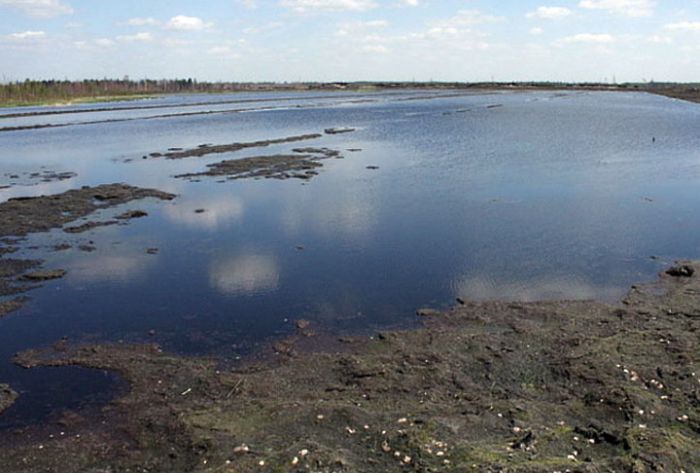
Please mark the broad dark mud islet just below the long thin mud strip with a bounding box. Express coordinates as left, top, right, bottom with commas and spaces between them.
175, 154, 323, 179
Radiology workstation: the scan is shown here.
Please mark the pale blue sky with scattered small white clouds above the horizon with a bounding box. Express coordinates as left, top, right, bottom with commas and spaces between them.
0, 0, 700, 82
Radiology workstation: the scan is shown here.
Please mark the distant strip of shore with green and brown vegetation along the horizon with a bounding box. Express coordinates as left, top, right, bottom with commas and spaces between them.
0, 78, 700, 107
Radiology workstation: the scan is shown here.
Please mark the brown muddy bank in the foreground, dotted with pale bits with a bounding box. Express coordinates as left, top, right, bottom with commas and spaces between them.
0, 262, 700, 473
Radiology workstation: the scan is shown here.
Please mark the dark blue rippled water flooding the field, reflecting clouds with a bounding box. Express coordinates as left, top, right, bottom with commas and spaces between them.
0, 87, 700, 425
